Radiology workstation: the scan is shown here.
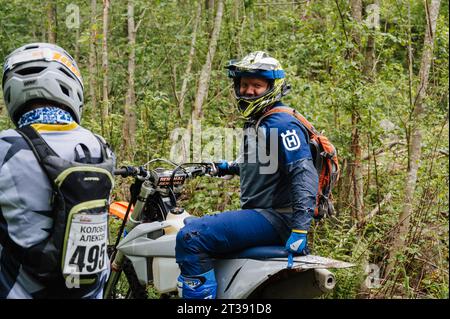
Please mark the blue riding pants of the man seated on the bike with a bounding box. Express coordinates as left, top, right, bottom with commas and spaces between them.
175, 209, 284, 276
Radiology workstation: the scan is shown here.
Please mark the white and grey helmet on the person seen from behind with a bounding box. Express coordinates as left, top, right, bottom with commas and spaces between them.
2, 43, 83, 123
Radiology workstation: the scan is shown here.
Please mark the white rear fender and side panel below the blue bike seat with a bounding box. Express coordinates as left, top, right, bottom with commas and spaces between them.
214, 255, 353, 299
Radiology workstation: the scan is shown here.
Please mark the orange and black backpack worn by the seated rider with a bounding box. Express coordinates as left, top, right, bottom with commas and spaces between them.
256, 107, 339, 220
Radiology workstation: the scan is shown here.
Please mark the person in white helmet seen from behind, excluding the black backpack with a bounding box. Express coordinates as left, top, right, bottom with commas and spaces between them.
0, 43, 114, 299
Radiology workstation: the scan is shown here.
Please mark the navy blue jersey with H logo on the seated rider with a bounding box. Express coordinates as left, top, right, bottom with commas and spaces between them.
237, 103, 319, 237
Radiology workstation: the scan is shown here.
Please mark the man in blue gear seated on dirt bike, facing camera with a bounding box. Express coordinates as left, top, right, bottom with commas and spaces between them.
176, 51, 318, 299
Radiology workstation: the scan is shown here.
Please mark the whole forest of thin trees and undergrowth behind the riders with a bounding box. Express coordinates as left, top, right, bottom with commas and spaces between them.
0, 0, 449, 298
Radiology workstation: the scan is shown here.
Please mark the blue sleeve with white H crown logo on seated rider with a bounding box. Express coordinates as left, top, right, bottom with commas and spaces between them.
264, 113, 319, 230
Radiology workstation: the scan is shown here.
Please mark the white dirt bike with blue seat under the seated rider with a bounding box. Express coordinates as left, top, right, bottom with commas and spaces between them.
104, 159, 353, 299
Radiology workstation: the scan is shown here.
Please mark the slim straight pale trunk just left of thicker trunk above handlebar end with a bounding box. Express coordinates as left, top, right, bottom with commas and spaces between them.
101, 0, 109, 135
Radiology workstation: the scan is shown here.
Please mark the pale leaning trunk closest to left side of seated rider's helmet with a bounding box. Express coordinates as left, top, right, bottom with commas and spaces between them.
193, 0, 223, 119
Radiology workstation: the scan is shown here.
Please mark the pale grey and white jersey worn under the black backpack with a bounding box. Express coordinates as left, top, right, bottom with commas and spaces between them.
0, 122, 109, 299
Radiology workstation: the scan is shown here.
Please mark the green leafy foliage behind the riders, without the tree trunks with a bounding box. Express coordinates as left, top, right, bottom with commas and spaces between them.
0, 0, 449, 298
